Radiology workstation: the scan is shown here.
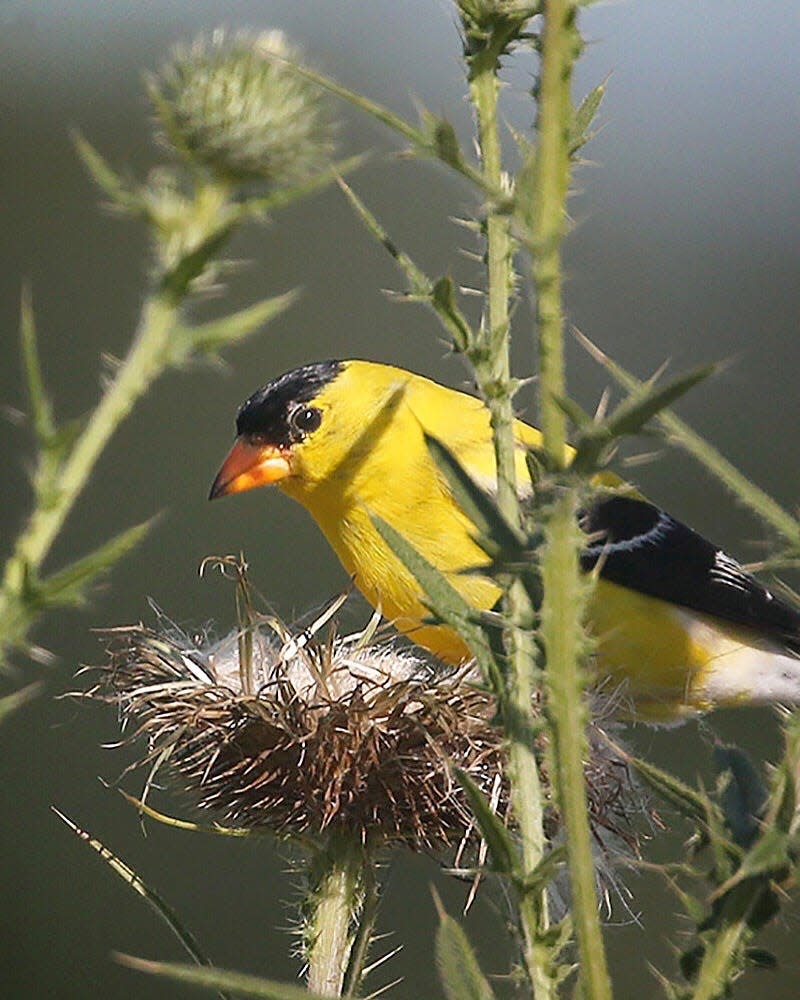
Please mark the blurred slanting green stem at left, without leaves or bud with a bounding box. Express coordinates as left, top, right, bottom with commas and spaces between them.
0, 295, 178, 600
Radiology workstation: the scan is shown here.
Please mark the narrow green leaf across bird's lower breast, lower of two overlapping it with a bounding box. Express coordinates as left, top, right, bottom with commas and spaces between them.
370, 514, 503, 691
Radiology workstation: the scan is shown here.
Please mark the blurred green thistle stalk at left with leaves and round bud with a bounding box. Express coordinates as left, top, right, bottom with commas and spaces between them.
0, 33, 348, 707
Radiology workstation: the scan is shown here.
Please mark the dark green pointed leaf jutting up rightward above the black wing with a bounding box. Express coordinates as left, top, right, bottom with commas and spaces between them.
572, 365, 716, 473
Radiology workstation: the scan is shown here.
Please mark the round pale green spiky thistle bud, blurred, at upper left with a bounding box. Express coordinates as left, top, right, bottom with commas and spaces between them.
149, 30, 333, 186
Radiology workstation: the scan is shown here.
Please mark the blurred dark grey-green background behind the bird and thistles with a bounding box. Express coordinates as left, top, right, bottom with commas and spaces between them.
0, 0, 800, 1000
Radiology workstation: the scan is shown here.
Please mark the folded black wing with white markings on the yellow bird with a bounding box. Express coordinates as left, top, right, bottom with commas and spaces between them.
581, 495, 800, 653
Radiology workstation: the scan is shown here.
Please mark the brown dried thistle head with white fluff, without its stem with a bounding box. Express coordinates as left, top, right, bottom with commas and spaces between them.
83, 600, 640, 868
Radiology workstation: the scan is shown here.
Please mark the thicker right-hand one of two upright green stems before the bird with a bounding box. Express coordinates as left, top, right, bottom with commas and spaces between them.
530, 0, 611, 1000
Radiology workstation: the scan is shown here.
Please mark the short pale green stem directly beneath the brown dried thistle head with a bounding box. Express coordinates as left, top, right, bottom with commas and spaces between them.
306, 834, 369, 997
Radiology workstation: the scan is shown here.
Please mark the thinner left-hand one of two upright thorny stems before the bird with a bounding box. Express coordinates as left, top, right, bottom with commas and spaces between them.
470, 27, 554, 1000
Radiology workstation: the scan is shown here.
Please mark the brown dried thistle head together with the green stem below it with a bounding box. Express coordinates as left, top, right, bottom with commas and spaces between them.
81, 557, 648, 996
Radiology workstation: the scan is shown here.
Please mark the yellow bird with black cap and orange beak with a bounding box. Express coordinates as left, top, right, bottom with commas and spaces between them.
211, 361, 800, 721
